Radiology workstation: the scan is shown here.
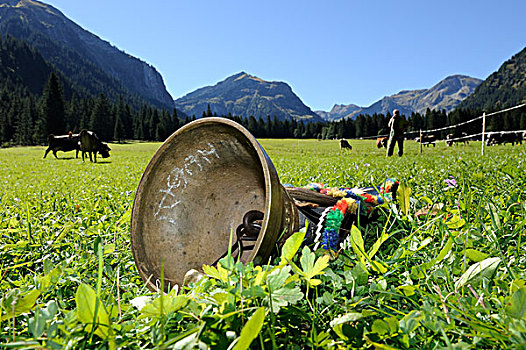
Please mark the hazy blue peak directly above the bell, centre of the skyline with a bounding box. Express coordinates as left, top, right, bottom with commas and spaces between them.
175, 72, 323, 122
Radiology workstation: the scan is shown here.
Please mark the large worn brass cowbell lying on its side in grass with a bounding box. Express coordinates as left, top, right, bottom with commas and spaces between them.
131, 118, 298, 290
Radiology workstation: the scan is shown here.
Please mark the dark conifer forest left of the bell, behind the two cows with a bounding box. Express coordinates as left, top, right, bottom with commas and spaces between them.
0, 73, 190, 145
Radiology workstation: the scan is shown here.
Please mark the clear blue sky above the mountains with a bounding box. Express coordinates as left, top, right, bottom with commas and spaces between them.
44, 0, 526, 110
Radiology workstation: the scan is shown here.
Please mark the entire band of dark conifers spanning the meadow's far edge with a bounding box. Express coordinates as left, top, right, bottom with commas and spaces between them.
0, 73, 526, 145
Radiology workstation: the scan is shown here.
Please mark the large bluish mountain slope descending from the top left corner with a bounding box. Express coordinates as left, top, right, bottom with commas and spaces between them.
0, 0, 173, 108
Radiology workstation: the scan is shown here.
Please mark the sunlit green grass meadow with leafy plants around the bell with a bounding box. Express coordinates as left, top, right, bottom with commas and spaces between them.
0, 139, 526, 349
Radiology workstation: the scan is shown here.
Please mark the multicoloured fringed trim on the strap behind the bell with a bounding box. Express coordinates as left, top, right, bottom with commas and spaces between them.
304, 179, 399, 251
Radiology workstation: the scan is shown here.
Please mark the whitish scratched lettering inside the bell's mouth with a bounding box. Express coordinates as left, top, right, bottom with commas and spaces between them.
154, 143, 219, 224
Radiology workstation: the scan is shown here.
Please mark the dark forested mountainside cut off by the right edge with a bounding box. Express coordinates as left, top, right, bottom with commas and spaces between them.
459, 48, 526, 111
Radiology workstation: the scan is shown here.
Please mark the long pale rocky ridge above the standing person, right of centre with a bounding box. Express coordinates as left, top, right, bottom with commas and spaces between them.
325, 75, 482, 120
